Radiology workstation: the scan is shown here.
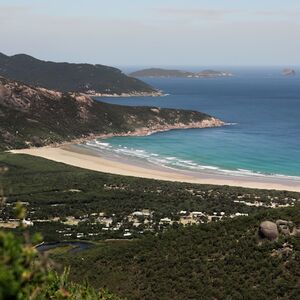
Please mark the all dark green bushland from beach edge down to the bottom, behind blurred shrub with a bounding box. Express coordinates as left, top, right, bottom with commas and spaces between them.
0, 153, 300, 299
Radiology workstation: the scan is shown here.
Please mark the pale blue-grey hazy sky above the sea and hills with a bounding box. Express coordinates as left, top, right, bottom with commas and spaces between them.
0, 0, 300, 67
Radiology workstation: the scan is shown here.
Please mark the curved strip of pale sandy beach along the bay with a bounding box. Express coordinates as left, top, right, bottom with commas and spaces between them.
11, 145, 300, 192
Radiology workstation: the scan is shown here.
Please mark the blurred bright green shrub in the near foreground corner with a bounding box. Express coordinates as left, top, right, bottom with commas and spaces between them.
0, 205, 119, 300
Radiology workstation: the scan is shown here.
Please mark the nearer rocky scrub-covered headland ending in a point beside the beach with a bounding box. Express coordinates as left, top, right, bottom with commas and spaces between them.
0, 77, 223, 149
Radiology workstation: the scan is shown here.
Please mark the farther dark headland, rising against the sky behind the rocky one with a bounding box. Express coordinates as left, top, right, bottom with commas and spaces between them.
0, 53, 159, 95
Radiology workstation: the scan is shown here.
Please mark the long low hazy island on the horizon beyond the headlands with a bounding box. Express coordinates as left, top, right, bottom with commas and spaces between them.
129, 68, 232, 78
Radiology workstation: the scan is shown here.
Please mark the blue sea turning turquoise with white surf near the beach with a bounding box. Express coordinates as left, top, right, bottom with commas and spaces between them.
90, 68, 300, 176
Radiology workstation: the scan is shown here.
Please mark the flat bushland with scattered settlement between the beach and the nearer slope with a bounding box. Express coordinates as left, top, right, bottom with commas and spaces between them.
0, 154, 300, 241
